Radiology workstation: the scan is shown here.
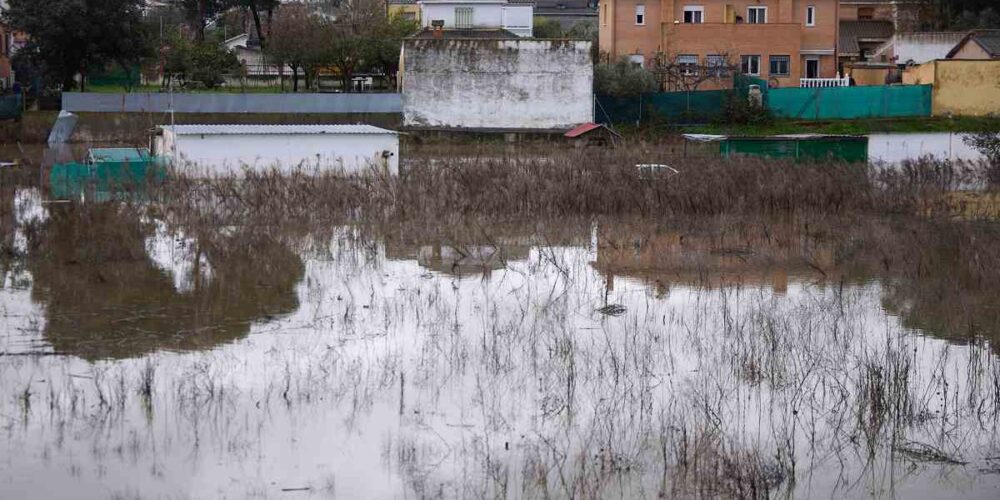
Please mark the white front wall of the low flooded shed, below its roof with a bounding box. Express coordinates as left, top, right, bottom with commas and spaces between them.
156, 129, 399, 176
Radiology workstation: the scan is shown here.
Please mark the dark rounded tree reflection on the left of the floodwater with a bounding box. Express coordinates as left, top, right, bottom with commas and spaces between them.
19, 204, 303, 359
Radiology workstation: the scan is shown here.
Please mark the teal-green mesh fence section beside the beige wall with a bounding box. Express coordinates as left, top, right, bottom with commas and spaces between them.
766, 85, 932, 120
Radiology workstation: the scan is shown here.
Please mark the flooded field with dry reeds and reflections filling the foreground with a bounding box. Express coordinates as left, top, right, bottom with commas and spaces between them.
0, 146, 1000, 499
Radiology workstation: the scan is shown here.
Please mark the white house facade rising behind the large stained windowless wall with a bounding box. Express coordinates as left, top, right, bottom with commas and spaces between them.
418, 0, 535, 37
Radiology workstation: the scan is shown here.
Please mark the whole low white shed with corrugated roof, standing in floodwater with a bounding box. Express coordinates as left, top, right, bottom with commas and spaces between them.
155, 125, 399, 175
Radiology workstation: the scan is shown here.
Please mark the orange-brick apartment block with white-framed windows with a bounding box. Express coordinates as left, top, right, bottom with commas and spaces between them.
598, 0, 840, 87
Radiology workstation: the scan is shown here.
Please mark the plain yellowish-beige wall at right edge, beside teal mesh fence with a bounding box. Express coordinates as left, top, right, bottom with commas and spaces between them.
933, 60, 1000, 116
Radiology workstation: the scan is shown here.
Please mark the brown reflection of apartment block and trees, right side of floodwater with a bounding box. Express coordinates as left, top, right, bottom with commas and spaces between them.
592, 218, 1000, 352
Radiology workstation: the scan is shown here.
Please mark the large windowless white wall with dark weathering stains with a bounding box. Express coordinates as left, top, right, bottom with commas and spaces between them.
401, 39, 594, 129
